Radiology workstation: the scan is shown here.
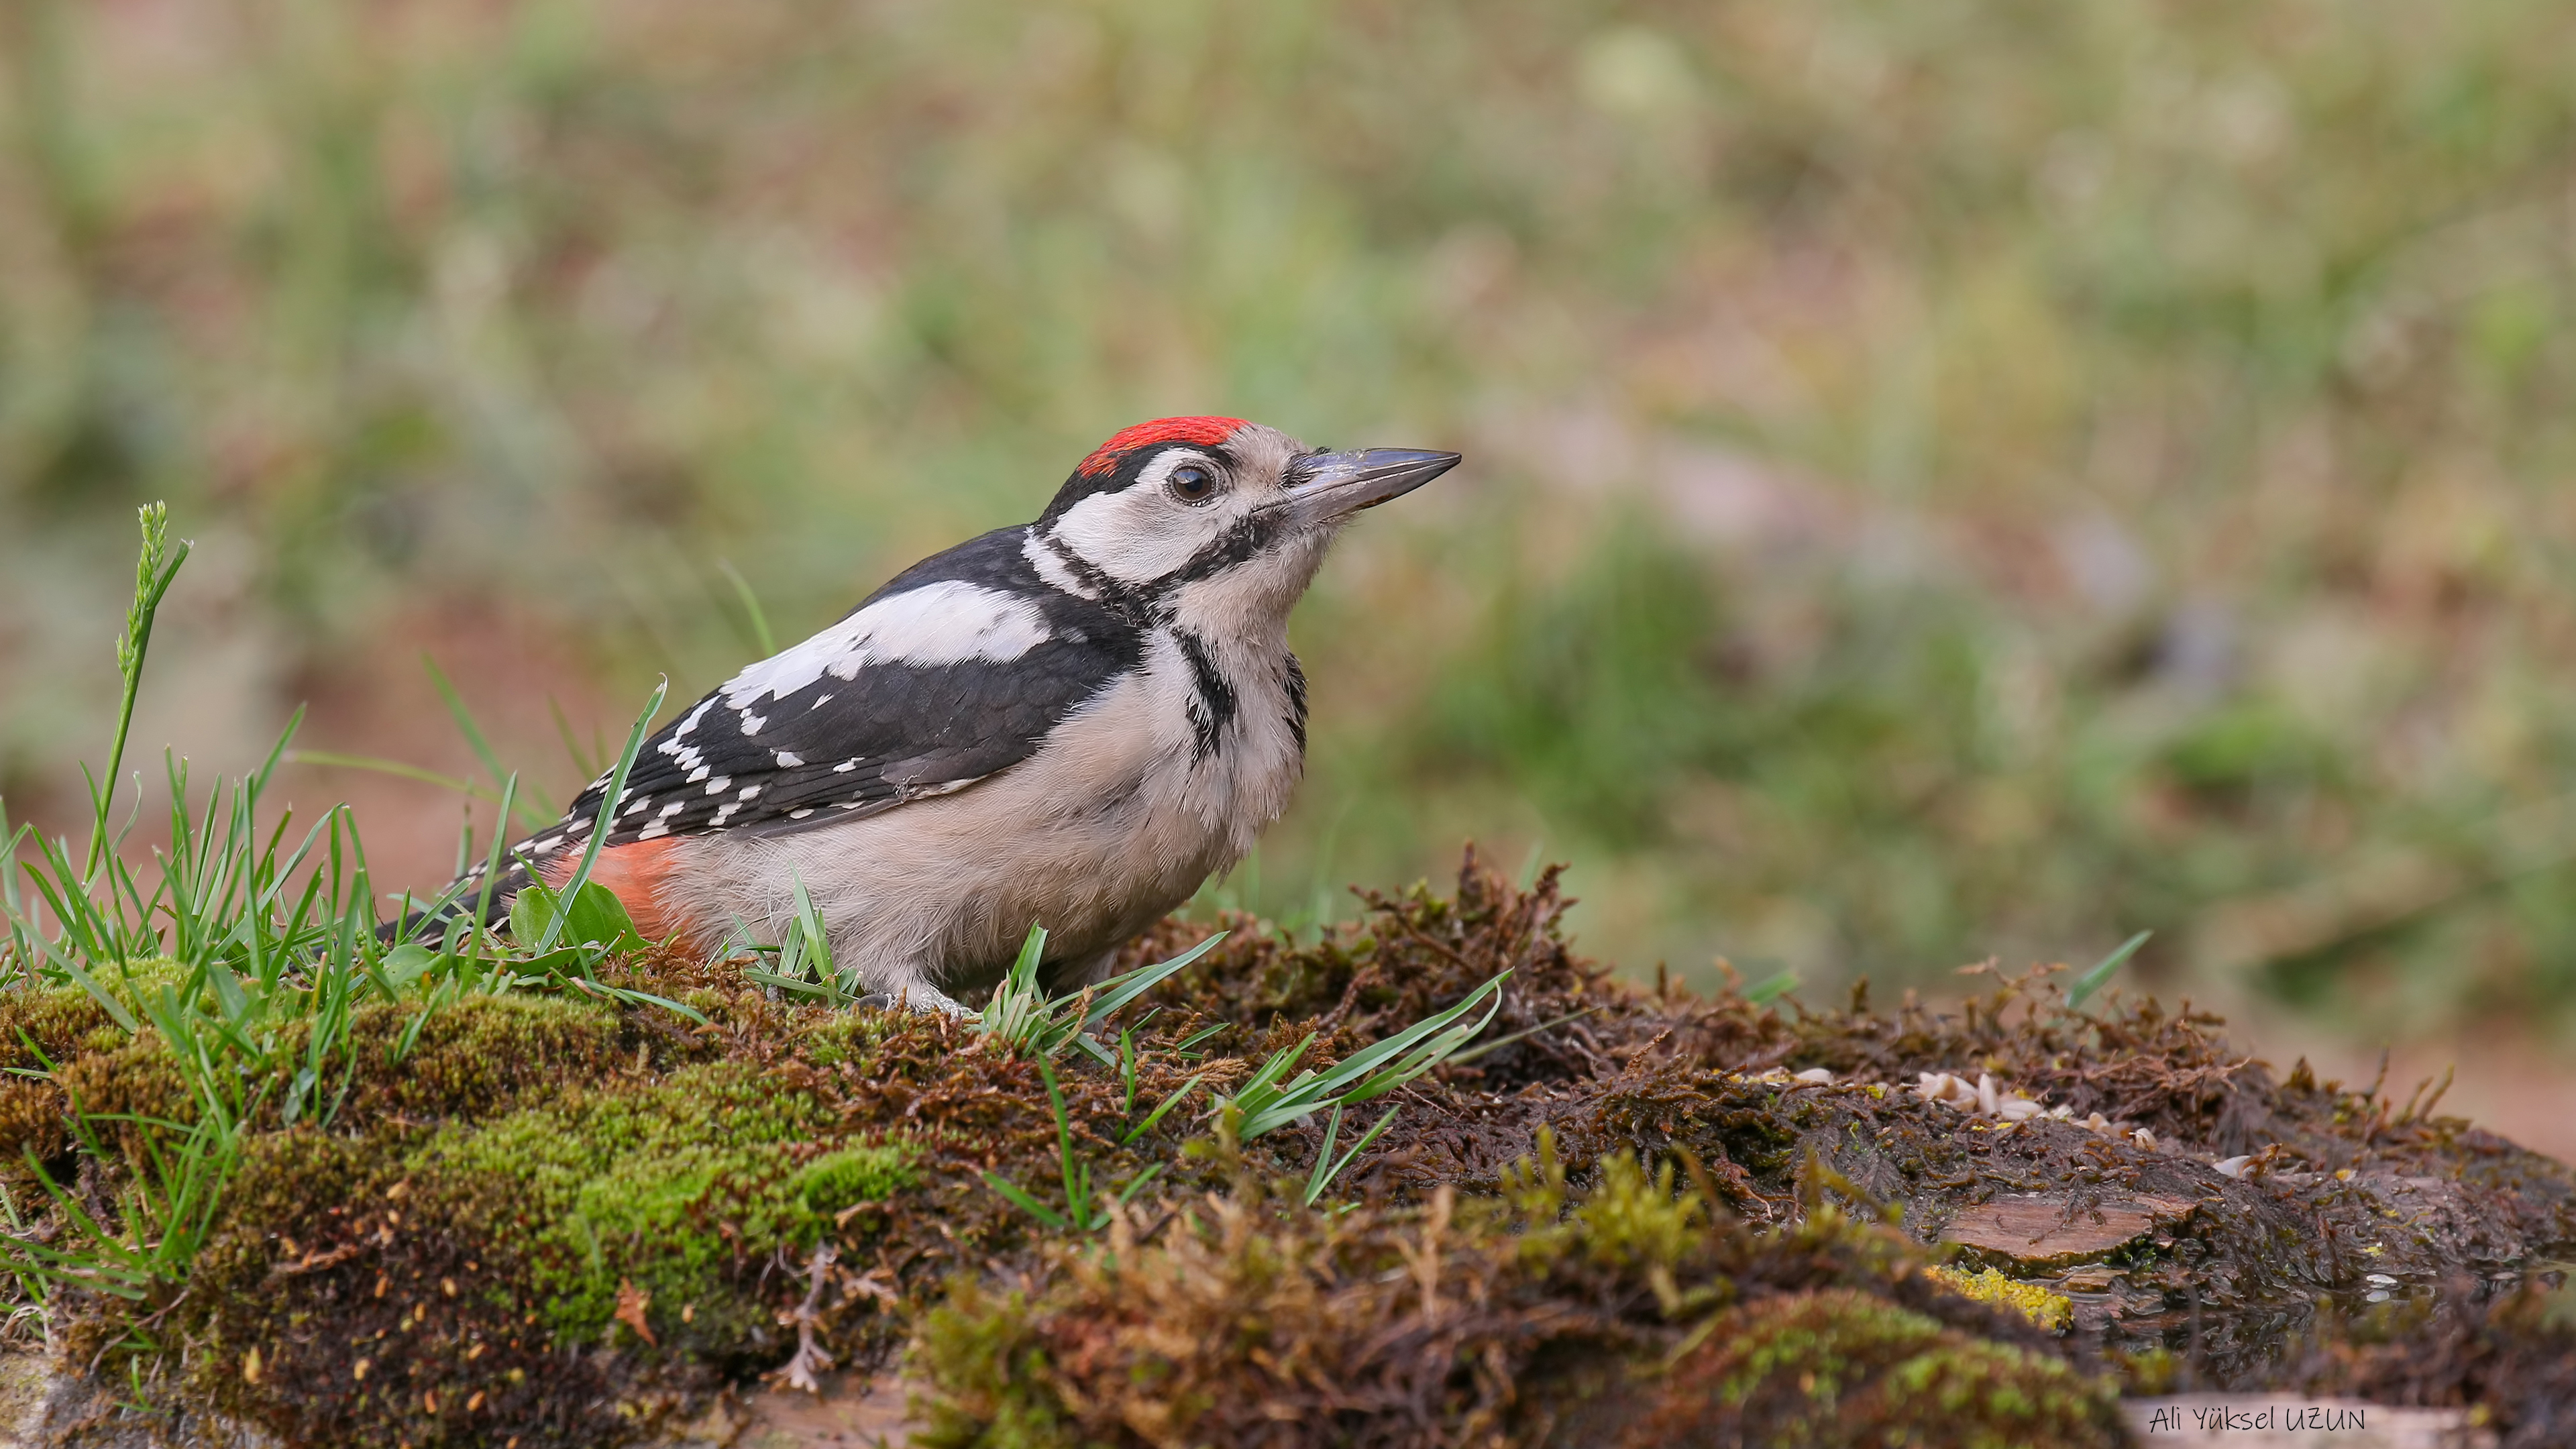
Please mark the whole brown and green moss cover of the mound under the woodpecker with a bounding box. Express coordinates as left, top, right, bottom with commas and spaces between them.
0, 859, 2576, 1449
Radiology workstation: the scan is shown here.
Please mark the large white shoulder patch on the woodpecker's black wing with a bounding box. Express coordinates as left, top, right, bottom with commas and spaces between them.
724, 580, 1049, 706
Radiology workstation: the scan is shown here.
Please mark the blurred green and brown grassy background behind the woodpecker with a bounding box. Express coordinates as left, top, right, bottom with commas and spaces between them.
0, 0, 2576, 1042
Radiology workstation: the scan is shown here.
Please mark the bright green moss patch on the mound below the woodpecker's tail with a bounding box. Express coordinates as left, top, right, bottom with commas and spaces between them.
410, 1062, 912, 1341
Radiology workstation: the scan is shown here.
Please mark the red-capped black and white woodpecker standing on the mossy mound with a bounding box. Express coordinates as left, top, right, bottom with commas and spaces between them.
453, 418, 1458, 1011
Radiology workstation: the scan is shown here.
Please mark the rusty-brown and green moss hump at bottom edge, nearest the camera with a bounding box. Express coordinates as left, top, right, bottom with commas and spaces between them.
914, 1139, 2112, 1449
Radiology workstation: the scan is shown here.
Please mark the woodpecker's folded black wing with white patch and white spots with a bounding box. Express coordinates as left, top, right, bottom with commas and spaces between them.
539, 529, 1141, 853
